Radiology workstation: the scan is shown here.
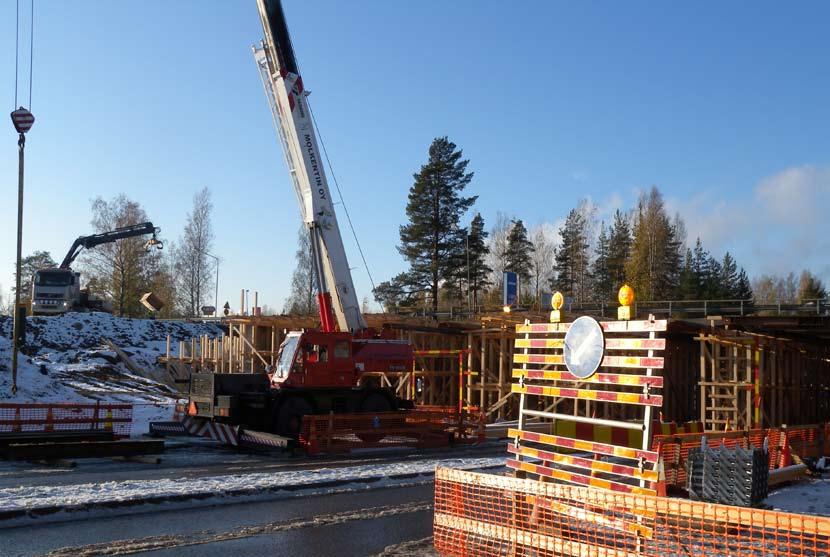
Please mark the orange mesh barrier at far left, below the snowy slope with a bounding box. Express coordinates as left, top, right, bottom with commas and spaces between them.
0, 402, 133, 438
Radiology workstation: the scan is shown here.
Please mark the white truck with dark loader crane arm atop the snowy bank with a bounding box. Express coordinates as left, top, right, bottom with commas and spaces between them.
31, 222, 163, 315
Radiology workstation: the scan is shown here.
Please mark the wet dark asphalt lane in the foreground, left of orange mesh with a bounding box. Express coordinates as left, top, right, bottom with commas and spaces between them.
0, 483, 442, 557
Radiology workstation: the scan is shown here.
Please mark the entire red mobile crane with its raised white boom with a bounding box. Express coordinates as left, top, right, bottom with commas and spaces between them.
188, 0, 413, 437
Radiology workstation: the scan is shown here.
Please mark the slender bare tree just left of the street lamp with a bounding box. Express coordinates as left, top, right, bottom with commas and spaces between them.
175, 188, 213, 316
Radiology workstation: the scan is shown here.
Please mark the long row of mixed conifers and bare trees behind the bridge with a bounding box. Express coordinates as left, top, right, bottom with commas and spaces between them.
374, 137, 827, 312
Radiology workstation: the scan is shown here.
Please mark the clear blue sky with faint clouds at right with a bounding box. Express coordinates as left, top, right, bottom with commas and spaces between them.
0, 0, 830, 308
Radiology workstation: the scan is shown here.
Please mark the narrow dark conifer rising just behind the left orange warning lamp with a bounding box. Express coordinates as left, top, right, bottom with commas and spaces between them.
551, 209, 590, 302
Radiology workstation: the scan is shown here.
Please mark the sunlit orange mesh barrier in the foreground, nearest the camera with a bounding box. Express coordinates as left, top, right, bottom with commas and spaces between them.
433, 468, 830, 557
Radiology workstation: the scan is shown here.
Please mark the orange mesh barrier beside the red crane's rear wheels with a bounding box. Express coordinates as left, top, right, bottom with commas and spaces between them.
300, 407, 485, 455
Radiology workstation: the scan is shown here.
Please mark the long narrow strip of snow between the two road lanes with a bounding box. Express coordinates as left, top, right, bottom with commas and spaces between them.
0, 456, 505, 511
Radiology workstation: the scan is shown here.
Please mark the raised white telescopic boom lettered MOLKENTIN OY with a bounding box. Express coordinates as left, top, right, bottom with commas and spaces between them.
254, 0, 366, 332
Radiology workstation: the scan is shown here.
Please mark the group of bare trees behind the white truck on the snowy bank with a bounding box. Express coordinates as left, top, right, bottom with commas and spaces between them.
7, 188, 216, 318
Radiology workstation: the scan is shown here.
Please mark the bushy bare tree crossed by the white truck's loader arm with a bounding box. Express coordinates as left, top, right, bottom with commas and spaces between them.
82, 194, 154, 315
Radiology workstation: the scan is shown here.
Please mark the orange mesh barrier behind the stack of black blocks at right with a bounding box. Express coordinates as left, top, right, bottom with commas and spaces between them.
652, 424, 830, 489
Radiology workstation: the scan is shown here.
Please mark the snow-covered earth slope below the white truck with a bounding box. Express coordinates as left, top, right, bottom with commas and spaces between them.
0, 313, 221, 435
